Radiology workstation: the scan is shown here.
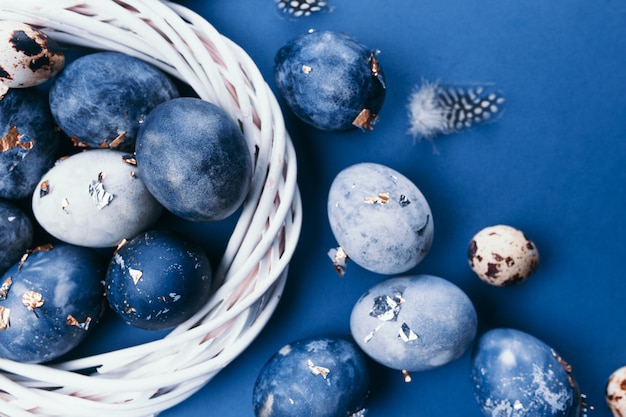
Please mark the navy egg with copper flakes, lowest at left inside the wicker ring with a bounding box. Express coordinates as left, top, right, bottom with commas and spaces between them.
0, 244, 105, 363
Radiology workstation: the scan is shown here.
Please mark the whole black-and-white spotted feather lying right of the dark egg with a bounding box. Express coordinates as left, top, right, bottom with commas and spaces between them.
408, 81, 504, 139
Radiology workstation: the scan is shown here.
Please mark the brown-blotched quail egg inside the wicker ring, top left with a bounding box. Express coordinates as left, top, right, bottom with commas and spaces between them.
0, 20, 65, 97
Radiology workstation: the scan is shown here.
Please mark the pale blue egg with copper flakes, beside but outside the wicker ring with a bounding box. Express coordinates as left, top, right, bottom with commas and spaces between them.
328, 162, 434, 275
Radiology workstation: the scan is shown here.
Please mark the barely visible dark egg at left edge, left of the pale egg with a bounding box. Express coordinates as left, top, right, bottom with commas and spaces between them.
0, 200, 33, 274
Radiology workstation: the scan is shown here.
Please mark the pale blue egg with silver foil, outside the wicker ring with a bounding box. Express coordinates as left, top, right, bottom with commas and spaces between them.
350, 275, 477, 371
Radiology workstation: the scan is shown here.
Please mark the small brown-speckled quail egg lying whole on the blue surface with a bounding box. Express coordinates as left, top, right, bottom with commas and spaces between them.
467, 225, 539, 287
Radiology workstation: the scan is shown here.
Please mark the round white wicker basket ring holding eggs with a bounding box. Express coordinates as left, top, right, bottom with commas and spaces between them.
0, 0, 302, 417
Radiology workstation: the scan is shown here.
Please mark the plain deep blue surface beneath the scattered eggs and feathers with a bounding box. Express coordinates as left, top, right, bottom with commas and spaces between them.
154, 0, 626, 417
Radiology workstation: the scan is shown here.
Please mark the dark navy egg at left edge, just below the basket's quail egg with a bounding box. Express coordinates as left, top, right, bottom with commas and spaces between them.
0, 89, 61, 200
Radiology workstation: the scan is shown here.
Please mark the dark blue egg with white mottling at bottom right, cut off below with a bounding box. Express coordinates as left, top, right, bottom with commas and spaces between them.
470, 328, 585, 417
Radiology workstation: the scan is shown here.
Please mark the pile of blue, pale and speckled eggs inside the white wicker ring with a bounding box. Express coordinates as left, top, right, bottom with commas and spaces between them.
0, 21, 253, 363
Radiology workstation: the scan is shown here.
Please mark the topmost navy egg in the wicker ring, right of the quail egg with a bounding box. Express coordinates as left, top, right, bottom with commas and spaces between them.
49, 52, 179, 149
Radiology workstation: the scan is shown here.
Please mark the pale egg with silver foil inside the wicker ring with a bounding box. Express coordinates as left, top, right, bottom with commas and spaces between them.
32, 149, 163, 248
